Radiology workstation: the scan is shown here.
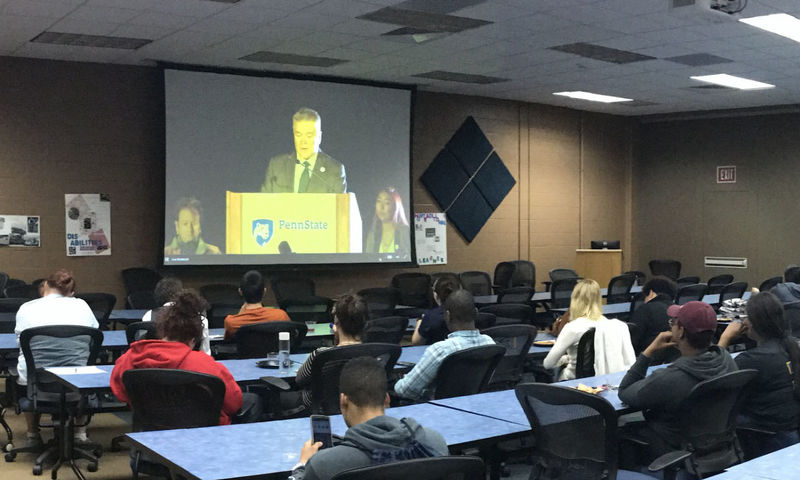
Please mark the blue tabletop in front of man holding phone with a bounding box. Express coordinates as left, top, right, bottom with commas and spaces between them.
128, 403, 528, 480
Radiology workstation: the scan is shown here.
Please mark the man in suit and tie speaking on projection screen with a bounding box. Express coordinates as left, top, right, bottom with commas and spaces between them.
261, 108, 347, 193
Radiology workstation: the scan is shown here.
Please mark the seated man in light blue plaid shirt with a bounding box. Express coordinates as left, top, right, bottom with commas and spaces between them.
394, 289, 494, 400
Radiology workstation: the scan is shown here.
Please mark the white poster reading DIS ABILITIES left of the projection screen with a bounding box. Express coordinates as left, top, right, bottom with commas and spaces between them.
64, 193, 111, 257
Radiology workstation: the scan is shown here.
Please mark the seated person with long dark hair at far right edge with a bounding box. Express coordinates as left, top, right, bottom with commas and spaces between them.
719, 292, 800, 455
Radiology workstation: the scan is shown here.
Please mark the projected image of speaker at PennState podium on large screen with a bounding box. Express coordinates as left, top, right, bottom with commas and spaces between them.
164, 69, 413, 265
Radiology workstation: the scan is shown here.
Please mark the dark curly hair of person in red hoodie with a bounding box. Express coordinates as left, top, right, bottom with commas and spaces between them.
156, 292, 208, 345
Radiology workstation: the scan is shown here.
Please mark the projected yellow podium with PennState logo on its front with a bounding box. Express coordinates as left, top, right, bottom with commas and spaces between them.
225, 191, 362, 255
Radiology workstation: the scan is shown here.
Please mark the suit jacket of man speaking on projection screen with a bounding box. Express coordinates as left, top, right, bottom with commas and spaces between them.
261, 151, 347, 193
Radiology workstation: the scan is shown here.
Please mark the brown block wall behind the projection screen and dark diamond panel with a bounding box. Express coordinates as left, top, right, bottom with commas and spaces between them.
0, 57, 636, 301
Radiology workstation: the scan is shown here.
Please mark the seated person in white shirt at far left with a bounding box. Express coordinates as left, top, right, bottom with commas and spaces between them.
14, 269, 99, 447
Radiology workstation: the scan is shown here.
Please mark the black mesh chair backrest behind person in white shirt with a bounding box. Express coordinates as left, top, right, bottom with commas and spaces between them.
19, 325, 103, 409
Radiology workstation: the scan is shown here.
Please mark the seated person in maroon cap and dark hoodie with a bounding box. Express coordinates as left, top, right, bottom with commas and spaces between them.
619, 302, 737, 461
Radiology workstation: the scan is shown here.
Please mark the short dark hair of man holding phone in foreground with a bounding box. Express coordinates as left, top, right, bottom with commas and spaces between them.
339, 357, 386, 407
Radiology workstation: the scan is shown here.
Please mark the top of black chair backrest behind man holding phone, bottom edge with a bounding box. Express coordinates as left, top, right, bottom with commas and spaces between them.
332, 456, 486, 480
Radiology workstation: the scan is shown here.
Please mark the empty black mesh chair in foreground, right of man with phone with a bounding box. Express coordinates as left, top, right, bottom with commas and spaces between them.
514, 383, 652, 480
